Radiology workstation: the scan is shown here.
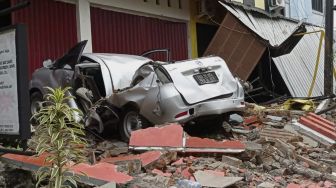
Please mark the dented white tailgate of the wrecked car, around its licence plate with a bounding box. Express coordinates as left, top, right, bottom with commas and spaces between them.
163, 57, 238, 104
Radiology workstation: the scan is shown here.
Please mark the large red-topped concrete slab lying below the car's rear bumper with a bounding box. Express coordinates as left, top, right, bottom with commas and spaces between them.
129, 124, 245, 153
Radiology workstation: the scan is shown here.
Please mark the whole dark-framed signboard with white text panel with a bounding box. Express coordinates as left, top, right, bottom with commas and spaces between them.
0, 25, 30, 139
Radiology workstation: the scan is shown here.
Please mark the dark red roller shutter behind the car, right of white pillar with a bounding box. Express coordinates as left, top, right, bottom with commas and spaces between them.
91, 7, 188, 60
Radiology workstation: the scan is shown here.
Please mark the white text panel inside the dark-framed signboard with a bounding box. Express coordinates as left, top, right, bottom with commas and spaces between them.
0, 29, 19, 135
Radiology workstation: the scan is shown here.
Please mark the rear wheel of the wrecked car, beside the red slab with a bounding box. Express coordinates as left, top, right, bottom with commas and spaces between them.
119, 109, 150, 142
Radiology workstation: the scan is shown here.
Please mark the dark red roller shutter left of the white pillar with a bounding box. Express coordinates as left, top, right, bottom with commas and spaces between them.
11, 0, 77, 73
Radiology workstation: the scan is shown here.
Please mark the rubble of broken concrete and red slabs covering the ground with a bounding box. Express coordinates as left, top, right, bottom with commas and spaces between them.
0, 100, 336, 188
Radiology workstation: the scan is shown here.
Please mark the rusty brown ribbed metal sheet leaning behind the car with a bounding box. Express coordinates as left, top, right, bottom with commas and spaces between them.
205, 13, 266, 80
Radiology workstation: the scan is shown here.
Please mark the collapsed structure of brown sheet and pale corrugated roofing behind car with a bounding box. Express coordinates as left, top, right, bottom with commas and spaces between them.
204, 3, 334, 100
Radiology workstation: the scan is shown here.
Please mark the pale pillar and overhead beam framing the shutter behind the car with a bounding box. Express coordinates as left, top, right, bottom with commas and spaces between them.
71, 0, 195, 57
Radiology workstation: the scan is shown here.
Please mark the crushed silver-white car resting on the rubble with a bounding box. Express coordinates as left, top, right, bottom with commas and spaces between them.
30, 41, 245, 140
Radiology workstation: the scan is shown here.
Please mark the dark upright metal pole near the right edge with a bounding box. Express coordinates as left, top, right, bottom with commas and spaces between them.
324, 0, 334, 96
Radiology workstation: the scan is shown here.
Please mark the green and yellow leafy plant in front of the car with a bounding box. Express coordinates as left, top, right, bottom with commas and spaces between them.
33, 88, 87, 188
